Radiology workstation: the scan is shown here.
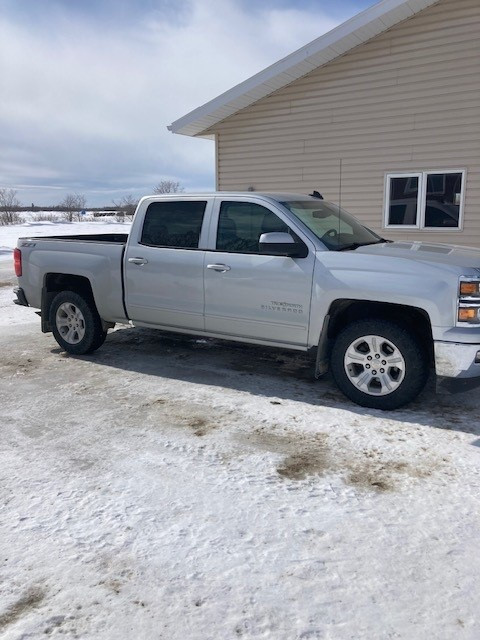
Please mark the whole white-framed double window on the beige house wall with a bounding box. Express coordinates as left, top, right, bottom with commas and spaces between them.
385, 171, 465, 229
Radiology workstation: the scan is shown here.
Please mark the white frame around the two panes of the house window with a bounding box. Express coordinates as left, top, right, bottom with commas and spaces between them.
383, 169, 467, 233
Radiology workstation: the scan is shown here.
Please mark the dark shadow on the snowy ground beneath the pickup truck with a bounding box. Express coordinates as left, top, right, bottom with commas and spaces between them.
68, 328, 480, 436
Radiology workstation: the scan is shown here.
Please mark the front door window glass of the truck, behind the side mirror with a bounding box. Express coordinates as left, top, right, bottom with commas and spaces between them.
217, 202, 288, 253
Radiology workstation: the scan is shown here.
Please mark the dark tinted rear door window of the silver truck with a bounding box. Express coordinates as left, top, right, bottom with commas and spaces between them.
140, 201, 207, 249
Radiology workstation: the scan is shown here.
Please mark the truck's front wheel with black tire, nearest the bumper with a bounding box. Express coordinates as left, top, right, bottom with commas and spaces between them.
330, 319, 429, 411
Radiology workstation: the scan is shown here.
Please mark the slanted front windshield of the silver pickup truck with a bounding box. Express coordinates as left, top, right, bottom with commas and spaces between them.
281, 198, 385, 251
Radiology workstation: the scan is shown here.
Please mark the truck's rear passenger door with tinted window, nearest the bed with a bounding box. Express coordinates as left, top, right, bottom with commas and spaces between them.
125, 198, 213, 330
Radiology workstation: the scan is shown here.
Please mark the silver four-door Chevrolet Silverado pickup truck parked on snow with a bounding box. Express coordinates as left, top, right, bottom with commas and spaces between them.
14, 193, 480, 410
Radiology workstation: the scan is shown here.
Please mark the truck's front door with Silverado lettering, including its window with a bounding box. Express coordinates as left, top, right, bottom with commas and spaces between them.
205, 198, 315, 346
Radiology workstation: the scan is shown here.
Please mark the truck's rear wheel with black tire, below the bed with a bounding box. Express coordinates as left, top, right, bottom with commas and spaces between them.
50, 291, 107, 355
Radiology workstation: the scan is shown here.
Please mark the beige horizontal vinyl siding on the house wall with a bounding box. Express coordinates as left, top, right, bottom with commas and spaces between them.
212, 0, 480, 246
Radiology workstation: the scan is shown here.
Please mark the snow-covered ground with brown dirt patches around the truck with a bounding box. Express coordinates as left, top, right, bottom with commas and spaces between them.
0, 232, 480, 640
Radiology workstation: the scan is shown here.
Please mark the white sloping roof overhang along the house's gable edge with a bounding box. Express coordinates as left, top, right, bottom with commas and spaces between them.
167, 0, 439, 137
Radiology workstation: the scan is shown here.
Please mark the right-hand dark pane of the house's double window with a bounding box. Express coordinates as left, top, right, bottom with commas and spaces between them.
425, 173, 463, 229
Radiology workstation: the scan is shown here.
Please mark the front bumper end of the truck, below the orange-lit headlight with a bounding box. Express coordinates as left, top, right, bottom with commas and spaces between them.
434, 341, 480, 380
